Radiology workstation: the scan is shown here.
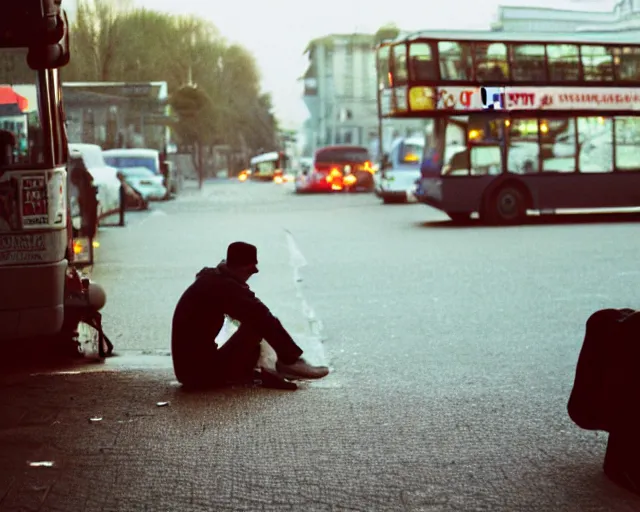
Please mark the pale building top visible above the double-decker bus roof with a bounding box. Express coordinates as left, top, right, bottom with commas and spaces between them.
491, 0, 640, 33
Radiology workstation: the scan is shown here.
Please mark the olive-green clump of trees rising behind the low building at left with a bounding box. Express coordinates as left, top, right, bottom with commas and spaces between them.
63, 0, 277, 176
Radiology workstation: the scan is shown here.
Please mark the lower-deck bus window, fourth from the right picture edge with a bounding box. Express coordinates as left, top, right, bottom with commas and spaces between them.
507, 119, 540, 174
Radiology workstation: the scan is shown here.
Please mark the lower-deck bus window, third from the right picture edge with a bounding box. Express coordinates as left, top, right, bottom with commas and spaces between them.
539, 118, 578, 172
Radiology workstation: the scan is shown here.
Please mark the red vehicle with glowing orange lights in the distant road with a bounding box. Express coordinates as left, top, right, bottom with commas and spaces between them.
295, 145, 374, 193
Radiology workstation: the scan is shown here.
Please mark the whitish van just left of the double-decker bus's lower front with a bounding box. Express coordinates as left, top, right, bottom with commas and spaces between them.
374, 137, 425, 204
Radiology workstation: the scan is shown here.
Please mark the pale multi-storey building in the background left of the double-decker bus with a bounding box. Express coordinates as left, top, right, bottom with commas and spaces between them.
302, 34, 424, 159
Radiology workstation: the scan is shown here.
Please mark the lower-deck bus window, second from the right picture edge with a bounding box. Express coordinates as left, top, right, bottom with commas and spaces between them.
578, 117, 613, 173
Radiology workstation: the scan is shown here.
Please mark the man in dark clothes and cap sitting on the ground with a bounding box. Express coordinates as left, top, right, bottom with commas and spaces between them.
171, 242, 329, 389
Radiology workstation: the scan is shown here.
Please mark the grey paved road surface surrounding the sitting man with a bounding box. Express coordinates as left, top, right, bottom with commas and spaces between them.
0, 182, 640, 512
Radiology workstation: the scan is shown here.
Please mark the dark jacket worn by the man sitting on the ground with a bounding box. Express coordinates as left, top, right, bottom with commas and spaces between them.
171, 262, 302, 380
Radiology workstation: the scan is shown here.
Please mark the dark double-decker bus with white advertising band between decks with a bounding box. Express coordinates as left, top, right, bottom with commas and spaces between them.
377, 31, 640, 224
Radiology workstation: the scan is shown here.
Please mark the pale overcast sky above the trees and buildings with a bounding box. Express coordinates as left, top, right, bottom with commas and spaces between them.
136, 0, 614, 127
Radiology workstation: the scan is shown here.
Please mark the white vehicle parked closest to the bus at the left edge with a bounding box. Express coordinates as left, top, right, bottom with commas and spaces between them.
69, 143, 121, 224
